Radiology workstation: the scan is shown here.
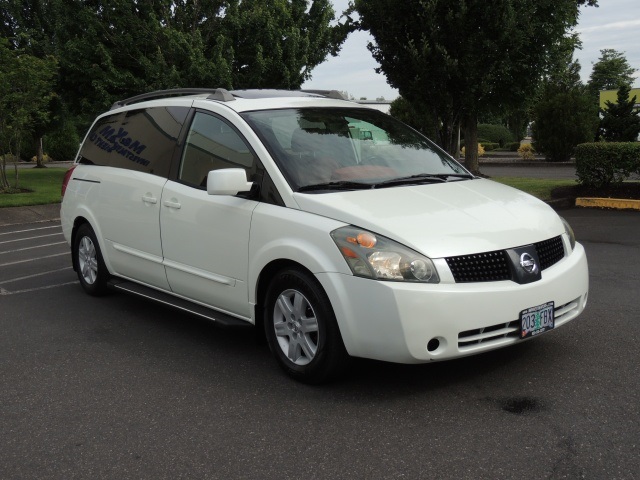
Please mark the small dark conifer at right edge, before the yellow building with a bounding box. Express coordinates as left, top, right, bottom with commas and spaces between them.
600, 84, 640, 142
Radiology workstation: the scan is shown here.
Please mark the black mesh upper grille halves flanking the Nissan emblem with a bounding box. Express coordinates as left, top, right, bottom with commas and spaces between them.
445, 237, 564, 283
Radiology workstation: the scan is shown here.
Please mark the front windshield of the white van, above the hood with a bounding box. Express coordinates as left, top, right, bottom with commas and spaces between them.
242, 107, 472, 192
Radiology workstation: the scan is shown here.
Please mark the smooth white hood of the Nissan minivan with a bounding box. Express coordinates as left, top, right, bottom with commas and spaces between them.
294, 179, 564, 258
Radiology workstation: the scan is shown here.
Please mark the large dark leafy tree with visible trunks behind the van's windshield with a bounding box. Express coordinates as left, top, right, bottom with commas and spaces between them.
346, 0, 597, 172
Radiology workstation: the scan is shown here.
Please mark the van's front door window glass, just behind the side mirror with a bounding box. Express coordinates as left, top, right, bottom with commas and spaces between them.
178, 112, 257, 187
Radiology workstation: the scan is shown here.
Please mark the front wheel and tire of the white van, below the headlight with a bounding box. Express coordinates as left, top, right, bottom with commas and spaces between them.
264, 268, 349, 384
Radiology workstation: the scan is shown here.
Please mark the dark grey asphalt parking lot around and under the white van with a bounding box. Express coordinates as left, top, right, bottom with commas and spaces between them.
0, 209, 640, 479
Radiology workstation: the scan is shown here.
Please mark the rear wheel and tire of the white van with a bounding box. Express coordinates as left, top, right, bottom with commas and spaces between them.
73, 223, 109, 296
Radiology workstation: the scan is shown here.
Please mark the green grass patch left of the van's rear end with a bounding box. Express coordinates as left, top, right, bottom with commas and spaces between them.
0, 165, 67, 208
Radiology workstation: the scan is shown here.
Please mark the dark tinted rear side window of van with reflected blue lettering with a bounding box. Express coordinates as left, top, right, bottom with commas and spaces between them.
80, 107, 189, 177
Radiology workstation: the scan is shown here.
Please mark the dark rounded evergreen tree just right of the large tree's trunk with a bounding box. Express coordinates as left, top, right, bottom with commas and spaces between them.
532, 62, 598, 162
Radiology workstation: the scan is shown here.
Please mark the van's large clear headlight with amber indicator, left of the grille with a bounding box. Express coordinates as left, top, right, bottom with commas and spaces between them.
331, 227, 440, 283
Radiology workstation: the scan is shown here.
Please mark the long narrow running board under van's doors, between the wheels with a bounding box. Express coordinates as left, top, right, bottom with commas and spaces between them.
107, 278, 253, 327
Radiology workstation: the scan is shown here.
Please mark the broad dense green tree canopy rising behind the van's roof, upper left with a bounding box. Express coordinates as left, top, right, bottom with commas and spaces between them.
0, 0, 346, 124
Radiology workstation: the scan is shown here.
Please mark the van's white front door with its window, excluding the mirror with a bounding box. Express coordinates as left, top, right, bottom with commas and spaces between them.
160, 112, 258, 319
